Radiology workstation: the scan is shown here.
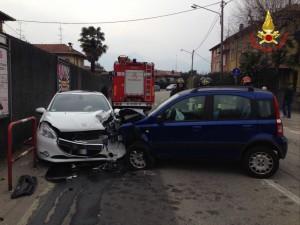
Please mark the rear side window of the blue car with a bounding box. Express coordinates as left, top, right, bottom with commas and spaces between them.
213, 95, 251, 120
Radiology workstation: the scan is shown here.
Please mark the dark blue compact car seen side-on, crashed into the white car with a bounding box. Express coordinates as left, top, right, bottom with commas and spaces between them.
120, 87, 287, 178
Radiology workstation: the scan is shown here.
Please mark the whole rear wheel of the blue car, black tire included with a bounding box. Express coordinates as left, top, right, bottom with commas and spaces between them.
242, 146, 279, 179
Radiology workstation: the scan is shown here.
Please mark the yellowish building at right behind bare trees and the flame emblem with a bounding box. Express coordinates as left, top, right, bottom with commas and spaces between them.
210, 4, 300, 109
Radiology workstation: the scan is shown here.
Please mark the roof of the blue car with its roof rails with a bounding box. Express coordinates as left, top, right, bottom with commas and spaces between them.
179, 86, 273, 97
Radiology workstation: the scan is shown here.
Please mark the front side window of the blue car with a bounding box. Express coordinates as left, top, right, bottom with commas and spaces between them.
164, 96, 205, 121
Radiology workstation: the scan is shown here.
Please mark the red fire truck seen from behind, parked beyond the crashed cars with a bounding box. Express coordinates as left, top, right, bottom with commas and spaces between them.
112, 56, 154, 110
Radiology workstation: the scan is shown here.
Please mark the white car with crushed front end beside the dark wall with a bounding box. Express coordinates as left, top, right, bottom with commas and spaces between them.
36, 91, 126, 163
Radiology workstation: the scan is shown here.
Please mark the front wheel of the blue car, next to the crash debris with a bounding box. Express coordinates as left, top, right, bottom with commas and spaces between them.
126, 142, 154, 170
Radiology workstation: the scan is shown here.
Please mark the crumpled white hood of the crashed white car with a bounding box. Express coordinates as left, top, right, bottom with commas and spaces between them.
41, 111, 110, 132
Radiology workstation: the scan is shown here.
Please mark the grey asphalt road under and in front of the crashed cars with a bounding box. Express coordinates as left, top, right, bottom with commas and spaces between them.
28, 91, 300, 225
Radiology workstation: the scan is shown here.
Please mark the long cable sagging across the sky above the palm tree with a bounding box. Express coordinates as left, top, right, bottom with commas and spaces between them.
16, 2, 220, 25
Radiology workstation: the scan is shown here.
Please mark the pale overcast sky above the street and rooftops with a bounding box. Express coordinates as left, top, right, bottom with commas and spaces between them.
1, 0, 237, 72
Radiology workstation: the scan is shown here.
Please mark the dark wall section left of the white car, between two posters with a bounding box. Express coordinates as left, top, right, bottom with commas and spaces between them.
10, 38, 57, 120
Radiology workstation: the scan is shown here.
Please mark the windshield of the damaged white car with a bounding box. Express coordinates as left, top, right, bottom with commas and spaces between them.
49, 94, 110, 112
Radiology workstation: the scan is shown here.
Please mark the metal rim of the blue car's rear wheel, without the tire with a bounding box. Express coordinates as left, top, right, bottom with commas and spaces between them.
249, 152, 274, 175
